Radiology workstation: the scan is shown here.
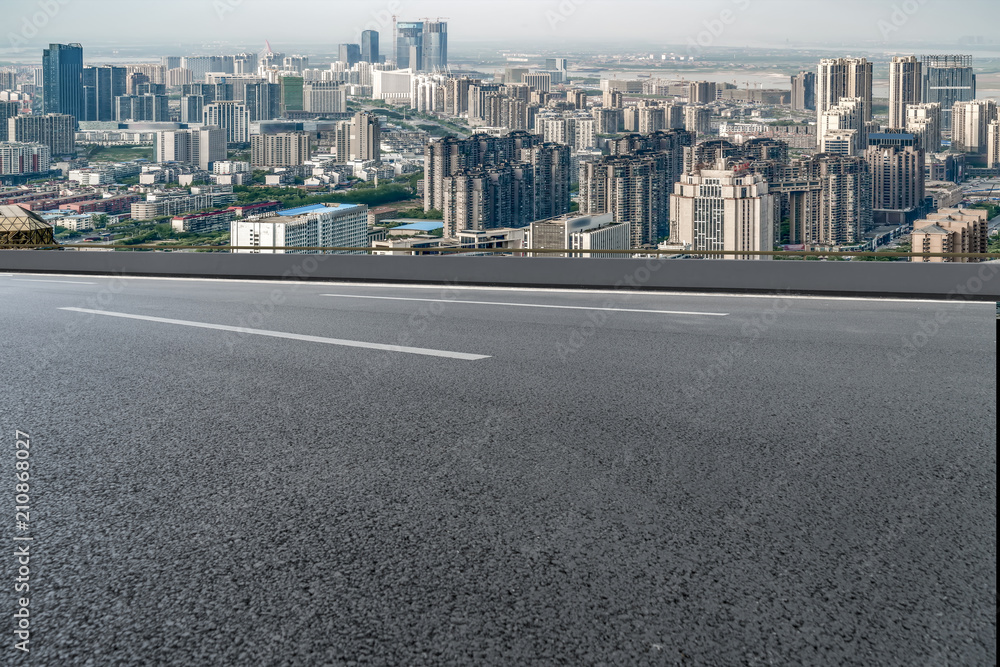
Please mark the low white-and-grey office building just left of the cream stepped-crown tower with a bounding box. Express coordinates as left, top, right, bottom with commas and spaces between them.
525, 213, 632, 258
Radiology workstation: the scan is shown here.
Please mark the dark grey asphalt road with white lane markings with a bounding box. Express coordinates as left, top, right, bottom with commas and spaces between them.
0, 275, 996, 666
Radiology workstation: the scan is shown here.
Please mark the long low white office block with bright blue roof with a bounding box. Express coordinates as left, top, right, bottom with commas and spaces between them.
230, 204, 368, 255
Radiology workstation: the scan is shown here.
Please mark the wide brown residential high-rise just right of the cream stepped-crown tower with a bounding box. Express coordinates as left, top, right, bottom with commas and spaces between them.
769, 154, 872, 247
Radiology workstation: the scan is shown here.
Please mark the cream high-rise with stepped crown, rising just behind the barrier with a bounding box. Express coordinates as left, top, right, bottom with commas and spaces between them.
670, 160, 776, 259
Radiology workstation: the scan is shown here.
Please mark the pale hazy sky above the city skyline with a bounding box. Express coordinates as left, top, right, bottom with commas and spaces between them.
0, 0, 1000, 57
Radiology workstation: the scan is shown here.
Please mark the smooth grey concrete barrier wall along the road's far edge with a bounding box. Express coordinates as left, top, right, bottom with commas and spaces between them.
0, 250, 1000, 301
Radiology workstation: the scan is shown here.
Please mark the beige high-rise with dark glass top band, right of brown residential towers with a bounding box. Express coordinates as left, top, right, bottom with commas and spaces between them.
865, 144, 924, 226
